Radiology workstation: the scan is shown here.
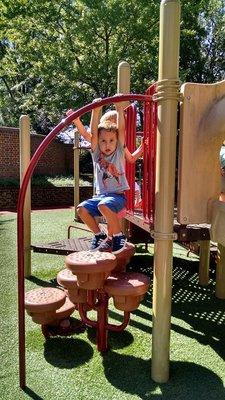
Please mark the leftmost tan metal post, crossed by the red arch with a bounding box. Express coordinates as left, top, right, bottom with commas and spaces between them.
19, 115, 31, 277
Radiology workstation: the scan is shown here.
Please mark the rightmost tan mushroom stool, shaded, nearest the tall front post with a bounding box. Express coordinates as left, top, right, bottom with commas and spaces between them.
104, 272, 150, 311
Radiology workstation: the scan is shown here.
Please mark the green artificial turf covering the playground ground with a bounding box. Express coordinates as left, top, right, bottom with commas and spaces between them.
0, 210, 225, 400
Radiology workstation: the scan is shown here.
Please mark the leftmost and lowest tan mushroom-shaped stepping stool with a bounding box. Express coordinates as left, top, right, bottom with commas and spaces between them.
25, 287, 71, 325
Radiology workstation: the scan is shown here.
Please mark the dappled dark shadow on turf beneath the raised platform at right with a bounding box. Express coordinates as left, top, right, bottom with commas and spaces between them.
126, 254, 225, 360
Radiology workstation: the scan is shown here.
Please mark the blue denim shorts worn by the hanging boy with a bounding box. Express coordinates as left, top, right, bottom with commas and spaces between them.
78, 193, 126, 217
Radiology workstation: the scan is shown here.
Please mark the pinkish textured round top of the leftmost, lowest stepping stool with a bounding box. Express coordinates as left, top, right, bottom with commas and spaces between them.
25, 287, 66, 312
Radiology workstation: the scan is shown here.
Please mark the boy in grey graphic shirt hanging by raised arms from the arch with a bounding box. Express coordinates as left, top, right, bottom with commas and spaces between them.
77, 103, 129, 254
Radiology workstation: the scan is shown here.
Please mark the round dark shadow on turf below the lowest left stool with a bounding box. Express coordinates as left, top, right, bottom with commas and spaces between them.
44, 337, 93, 369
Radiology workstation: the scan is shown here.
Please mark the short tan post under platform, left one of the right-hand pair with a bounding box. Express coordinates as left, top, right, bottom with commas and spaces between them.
199, 240, 210, 286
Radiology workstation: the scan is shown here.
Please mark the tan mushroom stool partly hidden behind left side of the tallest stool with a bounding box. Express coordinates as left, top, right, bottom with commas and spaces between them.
57, 268, 87, 304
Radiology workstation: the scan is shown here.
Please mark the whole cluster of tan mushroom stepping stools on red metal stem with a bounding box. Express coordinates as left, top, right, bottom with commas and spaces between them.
25, 244, 149, 352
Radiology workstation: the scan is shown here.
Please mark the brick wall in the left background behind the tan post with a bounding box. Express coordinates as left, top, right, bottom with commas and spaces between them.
0, 127, 73, 179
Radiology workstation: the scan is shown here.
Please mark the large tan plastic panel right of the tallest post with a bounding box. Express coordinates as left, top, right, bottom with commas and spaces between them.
178, 81, 225, 224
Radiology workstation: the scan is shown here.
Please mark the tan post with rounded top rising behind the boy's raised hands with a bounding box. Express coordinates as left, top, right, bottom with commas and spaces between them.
117, 61, 130, 235
